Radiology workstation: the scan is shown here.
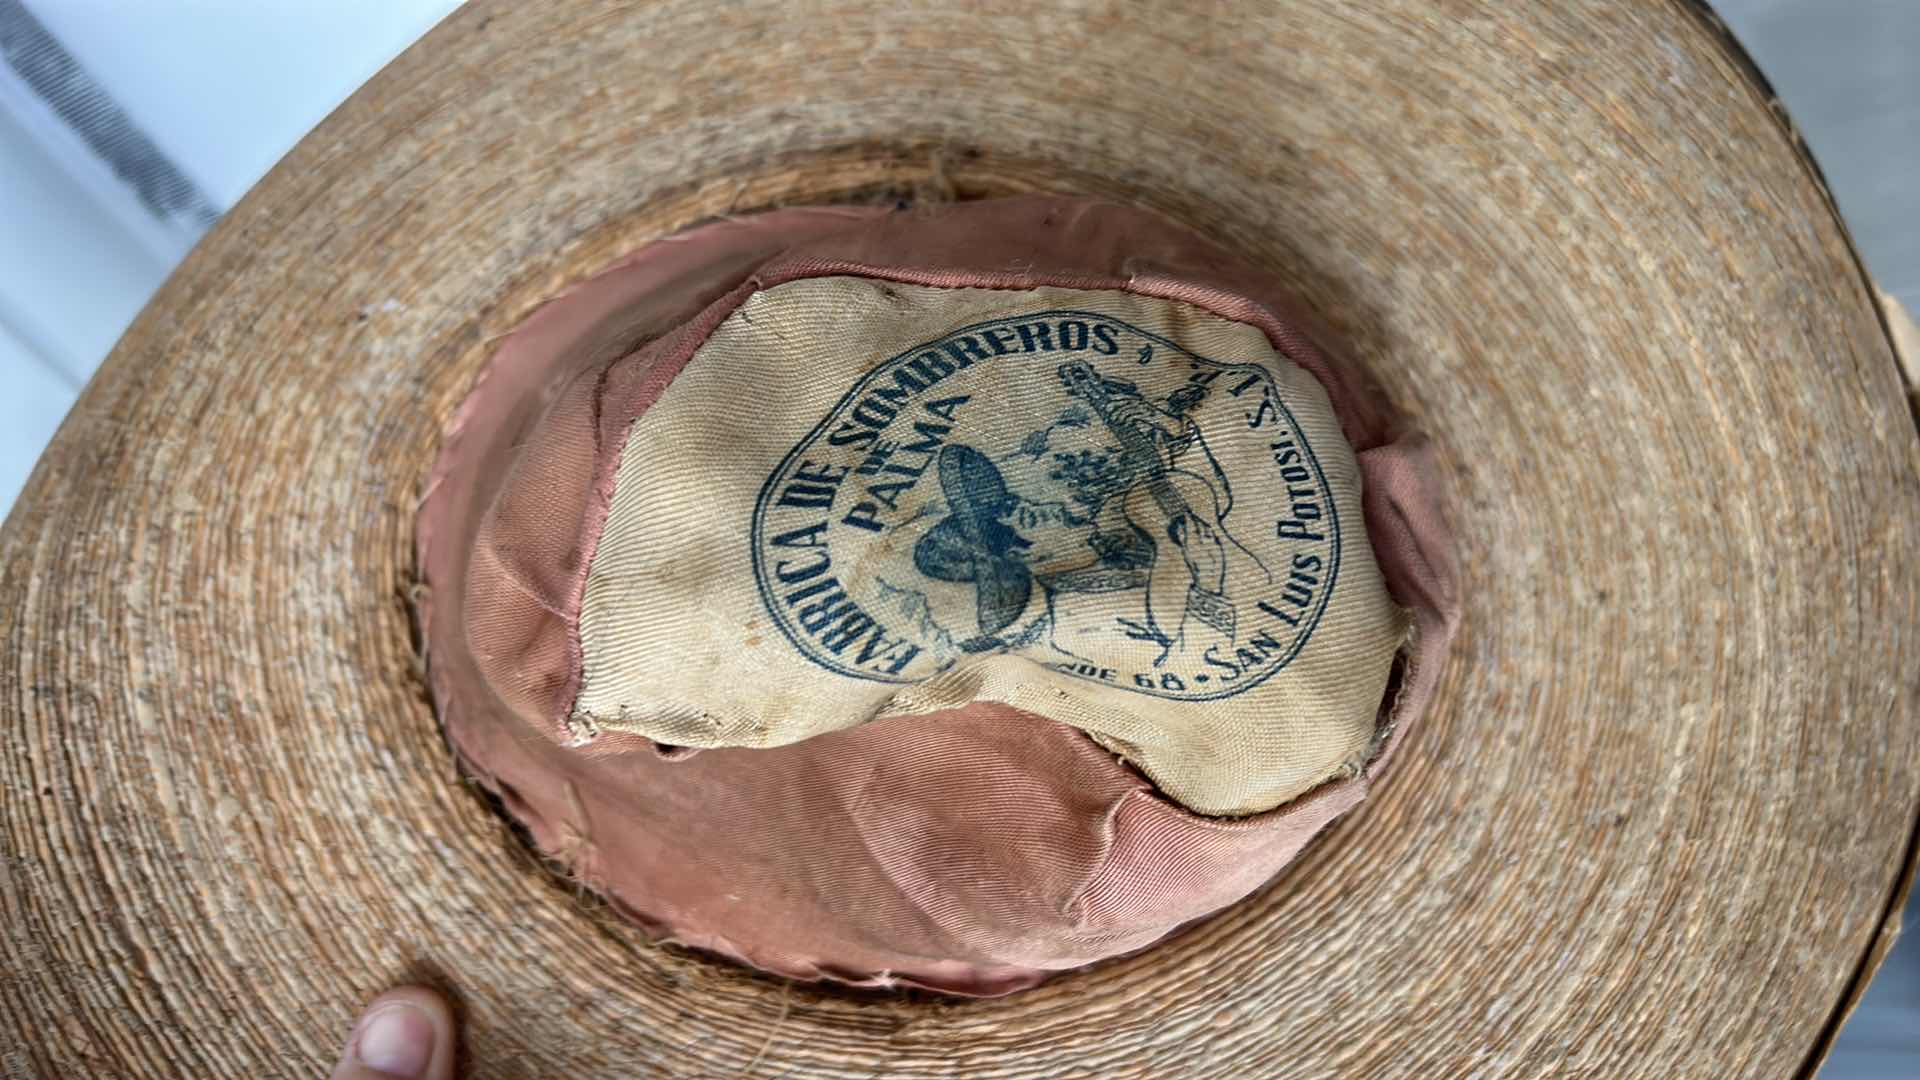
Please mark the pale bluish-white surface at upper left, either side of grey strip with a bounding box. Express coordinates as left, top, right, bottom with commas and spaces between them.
0, 0, 459, 513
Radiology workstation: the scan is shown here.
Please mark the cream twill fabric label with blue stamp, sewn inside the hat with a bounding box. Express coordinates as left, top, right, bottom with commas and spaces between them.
574, 277, 1405, 815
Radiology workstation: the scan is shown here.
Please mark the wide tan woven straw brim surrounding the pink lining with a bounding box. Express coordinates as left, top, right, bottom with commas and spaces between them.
0, 0, 1920, 1076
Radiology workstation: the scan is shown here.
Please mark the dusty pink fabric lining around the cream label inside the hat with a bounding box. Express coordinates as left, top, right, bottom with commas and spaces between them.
419, 196, 1457, 995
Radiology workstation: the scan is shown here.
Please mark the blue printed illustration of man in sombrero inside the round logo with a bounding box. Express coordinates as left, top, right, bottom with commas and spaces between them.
914, 361, 1271, 667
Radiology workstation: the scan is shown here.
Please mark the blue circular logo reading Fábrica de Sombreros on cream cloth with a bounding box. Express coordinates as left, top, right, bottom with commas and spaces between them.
753, 311, 1340, 700
